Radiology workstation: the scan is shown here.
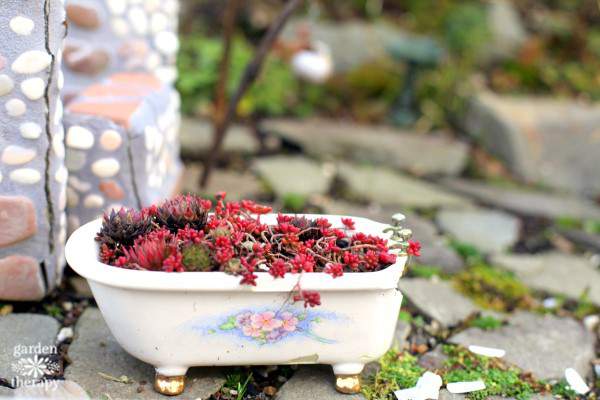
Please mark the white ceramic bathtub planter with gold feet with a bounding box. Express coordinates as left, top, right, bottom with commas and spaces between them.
66, 215, 407, 394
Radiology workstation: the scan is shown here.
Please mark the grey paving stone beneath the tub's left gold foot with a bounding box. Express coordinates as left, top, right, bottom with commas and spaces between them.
65, 308, 225, 399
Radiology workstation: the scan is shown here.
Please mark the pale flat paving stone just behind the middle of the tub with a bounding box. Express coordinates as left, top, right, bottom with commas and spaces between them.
254, 156, 333, 198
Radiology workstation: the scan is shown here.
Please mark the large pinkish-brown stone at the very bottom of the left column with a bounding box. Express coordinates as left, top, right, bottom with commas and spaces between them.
0, 256, 45, 300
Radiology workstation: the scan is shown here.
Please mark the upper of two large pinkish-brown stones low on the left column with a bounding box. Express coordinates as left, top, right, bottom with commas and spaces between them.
0, 196, 37, 248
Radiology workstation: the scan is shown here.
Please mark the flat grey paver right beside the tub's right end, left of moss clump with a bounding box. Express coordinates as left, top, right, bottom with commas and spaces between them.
398, 278, 479, 326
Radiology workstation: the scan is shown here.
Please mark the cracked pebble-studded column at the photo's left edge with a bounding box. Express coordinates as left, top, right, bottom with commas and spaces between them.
0, 0, 67, 300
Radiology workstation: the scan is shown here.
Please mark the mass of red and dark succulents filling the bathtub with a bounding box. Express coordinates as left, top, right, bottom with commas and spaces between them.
96, 192, 410, 306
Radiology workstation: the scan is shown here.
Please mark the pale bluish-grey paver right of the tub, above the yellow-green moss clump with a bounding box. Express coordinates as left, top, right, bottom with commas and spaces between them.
436, 209, 521, 253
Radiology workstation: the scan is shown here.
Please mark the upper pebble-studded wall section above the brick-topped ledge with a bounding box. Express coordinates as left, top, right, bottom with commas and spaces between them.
63, 0, 179, 100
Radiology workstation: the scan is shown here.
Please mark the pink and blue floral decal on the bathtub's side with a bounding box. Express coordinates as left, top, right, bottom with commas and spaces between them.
196, 309, 337, 345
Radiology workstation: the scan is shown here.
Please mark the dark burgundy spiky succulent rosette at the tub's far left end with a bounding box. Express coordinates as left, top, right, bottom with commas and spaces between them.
96, 207, 152, 249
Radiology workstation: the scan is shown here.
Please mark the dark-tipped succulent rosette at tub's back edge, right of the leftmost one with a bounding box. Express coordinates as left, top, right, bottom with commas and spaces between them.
154, 195, 208, 233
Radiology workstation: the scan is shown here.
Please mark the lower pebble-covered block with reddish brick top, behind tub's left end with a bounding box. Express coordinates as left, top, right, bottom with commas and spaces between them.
64, 73, 182, 232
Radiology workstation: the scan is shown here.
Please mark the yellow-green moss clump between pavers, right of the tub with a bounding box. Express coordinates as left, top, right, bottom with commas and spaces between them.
454, 264, 531, 311
